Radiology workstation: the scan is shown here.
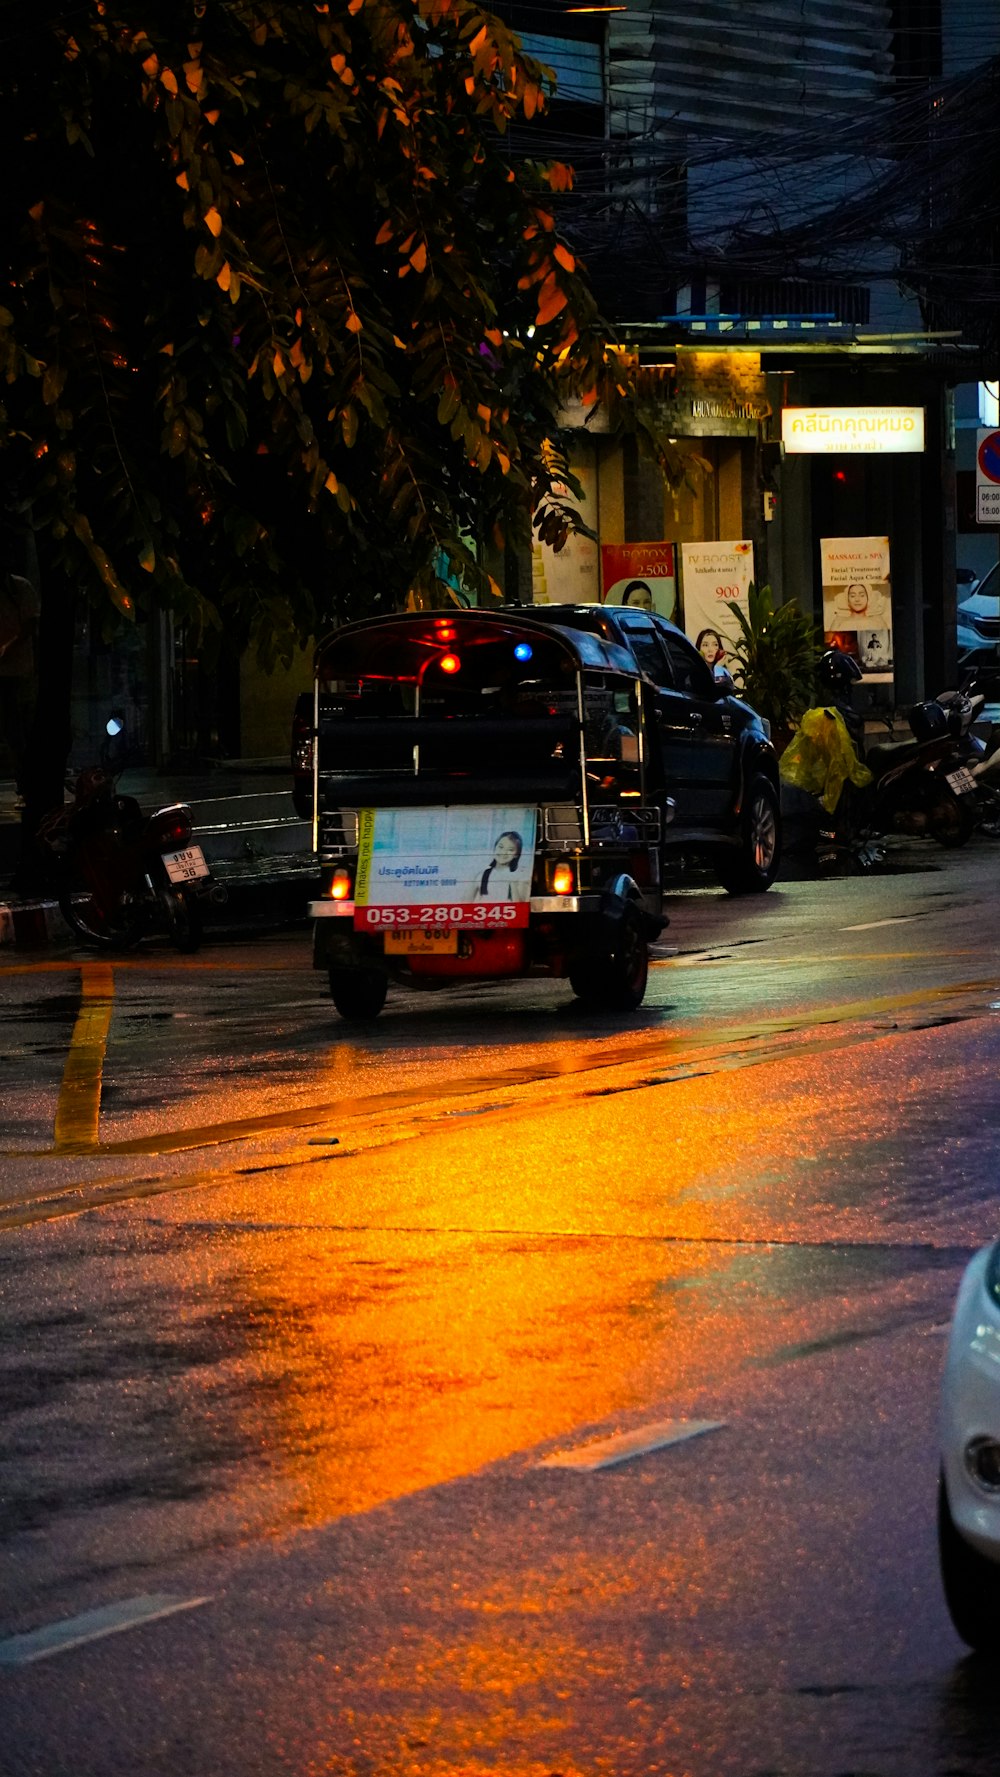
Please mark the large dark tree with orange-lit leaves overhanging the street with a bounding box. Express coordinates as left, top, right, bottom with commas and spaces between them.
0, 0, 602, 845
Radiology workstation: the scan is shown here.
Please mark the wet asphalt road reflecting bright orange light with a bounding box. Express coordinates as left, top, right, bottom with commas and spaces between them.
0, 844, 1000, 1777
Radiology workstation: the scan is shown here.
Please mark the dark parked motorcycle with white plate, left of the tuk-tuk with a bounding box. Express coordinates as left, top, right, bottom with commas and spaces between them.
39, 766, 226, 951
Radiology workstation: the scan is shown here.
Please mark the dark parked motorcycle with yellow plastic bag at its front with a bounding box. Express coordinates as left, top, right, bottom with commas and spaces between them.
782, 649, 980, 869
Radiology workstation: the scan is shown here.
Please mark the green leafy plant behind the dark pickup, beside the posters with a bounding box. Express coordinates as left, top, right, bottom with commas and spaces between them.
726, 581, 822, 752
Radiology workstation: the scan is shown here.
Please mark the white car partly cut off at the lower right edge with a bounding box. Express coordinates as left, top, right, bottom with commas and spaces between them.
938, 1240, 1000, 1653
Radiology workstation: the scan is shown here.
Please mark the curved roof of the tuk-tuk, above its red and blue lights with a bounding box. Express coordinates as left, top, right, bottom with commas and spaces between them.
314, 606, 639, 679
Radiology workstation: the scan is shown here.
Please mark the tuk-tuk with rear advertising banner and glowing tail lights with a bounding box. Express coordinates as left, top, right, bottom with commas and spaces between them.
302, 610, 671, 1020
